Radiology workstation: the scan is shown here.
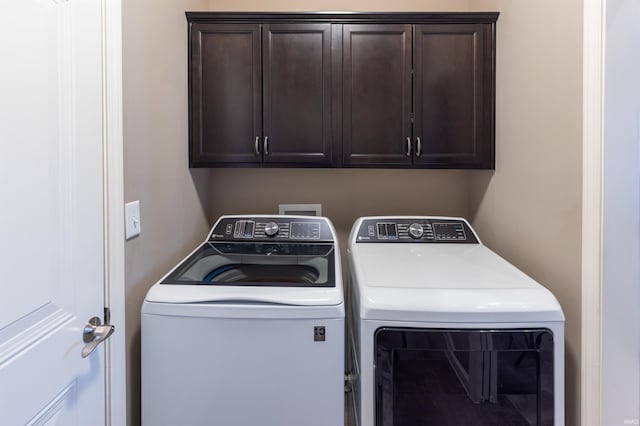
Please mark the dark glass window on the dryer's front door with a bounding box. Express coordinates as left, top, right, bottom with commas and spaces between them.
375, 328, 553, 426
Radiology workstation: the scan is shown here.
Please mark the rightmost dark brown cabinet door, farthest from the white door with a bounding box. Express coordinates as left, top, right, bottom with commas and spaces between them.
414, 24, 494, 168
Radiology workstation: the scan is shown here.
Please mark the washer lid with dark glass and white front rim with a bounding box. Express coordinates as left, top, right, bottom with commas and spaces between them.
145, 242, 343, 306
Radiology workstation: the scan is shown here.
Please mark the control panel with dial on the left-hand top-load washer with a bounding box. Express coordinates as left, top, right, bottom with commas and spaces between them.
209, 216, 333, 242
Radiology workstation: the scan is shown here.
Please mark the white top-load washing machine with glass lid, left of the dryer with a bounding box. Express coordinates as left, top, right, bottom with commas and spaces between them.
141, 216, 345, 426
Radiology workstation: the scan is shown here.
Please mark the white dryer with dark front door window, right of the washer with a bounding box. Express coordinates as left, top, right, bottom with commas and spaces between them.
347, 217, 564, 426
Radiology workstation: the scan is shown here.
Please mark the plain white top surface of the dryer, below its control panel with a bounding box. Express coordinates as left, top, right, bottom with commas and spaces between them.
349, 216, 564, 322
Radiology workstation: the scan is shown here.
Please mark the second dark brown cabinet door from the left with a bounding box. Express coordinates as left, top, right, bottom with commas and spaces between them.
262, 24, 334, 165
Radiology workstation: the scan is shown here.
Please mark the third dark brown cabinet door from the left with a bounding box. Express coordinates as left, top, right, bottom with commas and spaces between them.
342, 24, 412, 166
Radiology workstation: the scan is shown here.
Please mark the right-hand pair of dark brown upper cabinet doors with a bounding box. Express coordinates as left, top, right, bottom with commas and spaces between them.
342, 23, 494, 168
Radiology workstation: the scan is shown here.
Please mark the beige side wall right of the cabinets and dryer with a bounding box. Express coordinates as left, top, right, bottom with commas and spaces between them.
469, 0, 582, 425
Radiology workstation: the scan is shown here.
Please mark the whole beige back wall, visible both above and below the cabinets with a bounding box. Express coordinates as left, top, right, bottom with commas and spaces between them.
208, 0, 476, 270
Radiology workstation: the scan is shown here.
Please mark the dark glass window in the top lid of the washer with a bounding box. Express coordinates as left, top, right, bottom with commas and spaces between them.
162, 243, 335, 287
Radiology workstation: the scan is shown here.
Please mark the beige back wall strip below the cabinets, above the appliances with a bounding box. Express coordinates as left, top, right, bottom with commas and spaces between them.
209, 169, 468, 266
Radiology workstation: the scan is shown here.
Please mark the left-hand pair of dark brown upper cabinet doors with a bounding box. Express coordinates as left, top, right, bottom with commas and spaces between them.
189, 22, 334, 167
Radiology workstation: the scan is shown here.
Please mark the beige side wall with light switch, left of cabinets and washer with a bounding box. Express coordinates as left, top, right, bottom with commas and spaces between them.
123, 0, 209, 425
